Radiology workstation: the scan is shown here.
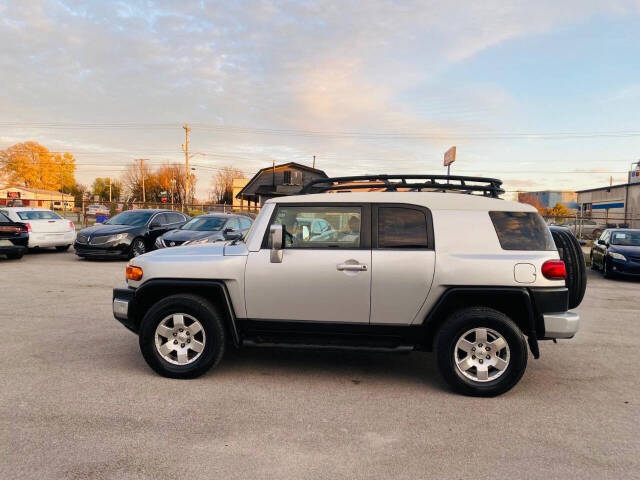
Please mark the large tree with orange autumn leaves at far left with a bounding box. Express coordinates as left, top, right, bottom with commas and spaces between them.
0, 142, 76, 193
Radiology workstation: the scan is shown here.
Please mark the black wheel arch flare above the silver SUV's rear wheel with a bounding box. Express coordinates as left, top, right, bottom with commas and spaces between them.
422, 287, 540, 358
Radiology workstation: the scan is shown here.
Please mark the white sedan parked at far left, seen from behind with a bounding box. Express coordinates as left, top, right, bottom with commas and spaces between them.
0, 207, 76, 252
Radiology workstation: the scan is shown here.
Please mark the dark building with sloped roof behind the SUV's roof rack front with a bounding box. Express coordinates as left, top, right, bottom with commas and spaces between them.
234, 162, 328, 207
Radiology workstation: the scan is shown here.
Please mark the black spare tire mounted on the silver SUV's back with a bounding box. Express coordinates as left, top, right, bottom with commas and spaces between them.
550, 227, 587, 309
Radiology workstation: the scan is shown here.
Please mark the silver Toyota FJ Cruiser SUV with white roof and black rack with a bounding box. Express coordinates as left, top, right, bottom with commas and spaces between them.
113, 175, 586, 396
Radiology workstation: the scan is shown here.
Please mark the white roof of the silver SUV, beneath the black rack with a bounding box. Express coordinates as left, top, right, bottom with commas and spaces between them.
266, 192, 537, 212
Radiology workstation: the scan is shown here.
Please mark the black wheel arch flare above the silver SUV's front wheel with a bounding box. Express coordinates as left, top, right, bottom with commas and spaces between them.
133, 278, 240, 347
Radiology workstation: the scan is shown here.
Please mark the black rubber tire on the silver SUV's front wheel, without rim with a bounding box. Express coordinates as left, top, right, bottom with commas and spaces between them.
139, 294, 226, 379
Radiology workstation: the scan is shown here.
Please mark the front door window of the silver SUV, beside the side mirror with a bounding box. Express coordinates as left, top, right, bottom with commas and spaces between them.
272, 205, 362, 248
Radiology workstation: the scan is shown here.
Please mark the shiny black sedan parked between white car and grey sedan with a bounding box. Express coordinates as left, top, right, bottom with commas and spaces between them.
74, 210, 189, 258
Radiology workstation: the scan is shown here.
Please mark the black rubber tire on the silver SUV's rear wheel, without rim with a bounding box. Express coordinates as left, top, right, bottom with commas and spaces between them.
435, 307, 529, 397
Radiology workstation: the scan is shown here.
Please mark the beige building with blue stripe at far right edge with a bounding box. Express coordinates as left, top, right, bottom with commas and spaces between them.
577, 181, 640, 228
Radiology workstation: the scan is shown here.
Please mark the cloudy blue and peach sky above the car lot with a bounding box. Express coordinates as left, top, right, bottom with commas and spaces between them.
0, 0, 640, 197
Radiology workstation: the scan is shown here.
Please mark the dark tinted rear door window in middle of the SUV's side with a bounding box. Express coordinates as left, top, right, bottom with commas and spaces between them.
378, 207, 429, 248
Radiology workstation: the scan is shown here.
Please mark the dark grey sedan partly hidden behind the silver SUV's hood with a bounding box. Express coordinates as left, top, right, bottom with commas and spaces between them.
155, 213, 253, 248
